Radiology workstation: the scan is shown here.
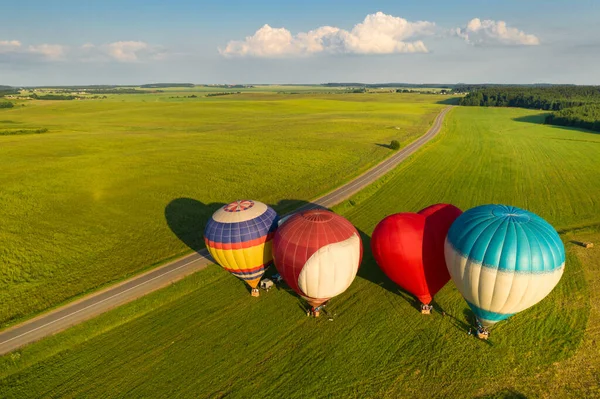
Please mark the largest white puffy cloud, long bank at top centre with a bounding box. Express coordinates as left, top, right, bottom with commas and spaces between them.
219, 12, 435, 57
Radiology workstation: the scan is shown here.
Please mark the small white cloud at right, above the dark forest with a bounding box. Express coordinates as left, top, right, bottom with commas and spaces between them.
452, 18, 540, 46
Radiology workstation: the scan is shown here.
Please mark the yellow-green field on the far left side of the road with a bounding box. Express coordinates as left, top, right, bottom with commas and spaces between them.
0, 93, 444, 326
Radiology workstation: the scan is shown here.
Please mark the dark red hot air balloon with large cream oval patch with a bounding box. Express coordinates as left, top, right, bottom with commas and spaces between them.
273, 210, 362, 317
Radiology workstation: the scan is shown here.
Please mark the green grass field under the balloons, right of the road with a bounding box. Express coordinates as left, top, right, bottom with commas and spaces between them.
0, 108, 600, 398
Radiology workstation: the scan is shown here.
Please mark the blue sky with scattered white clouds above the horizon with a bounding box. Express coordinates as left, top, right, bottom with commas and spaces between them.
0, 0, 600, 86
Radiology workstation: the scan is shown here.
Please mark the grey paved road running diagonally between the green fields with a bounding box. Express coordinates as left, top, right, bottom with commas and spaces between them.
0, 106, 452, 355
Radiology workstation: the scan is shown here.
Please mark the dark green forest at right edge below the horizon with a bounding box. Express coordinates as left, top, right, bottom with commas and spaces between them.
459, 85, 600, 131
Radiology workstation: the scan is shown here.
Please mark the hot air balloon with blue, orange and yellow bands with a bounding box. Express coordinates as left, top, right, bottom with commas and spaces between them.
204, 200, 279, 296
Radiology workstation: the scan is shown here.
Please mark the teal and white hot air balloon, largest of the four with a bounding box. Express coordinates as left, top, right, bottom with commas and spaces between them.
444, 205, 565, 327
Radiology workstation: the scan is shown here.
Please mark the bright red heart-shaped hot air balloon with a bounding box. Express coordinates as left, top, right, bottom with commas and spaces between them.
371, 204, 462, 314
